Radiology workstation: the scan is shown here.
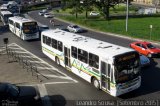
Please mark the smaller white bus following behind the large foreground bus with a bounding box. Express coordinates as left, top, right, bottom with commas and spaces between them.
8, 16, 39, 40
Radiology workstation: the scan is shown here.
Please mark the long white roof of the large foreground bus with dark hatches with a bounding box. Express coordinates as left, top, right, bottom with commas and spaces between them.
42, 29, 134, 59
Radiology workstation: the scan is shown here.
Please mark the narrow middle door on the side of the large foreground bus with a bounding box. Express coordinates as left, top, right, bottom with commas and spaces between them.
64, 47, 71, 69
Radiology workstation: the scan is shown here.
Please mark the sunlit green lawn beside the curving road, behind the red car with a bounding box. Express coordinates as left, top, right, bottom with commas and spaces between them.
59, 15, 160, 41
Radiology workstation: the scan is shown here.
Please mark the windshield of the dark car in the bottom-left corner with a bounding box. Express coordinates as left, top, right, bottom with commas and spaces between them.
6, 84, 20, 97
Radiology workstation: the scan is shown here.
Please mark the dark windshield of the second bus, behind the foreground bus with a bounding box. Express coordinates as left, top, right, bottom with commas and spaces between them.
23, 22, 38, 34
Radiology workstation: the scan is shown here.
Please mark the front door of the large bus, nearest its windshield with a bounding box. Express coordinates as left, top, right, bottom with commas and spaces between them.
101, 61, 111, 92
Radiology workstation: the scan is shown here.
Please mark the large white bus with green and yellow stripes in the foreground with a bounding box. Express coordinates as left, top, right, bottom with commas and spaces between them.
41, 29, 141, 96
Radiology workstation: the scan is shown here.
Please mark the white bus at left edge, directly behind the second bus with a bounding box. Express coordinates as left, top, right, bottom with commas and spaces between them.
0, 11, 13, 25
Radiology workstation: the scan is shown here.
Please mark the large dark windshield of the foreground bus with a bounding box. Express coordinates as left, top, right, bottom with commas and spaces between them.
115, 52, 140, 83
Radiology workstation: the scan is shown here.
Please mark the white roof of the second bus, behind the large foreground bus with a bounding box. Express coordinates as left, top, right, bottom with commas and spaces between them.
9, 16, 36, 23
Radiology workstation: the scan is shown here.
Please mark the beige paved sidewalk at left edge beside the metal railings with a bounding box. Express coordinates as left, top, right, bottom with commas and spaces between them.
0, 48, 39, 85
